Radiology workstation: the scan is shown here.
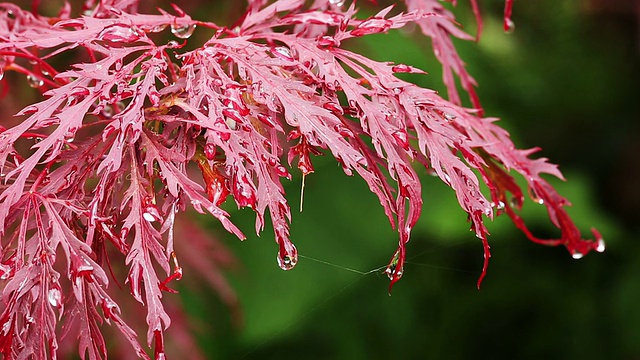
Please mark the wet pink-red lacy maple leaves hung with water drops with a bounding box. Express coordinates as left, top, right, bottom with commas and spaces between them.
0, 0, 604, 359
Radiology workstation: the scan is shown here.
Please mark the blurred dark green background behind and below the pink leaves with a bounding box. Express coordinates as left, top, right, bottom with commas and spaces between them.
186, 0, 640, 359
